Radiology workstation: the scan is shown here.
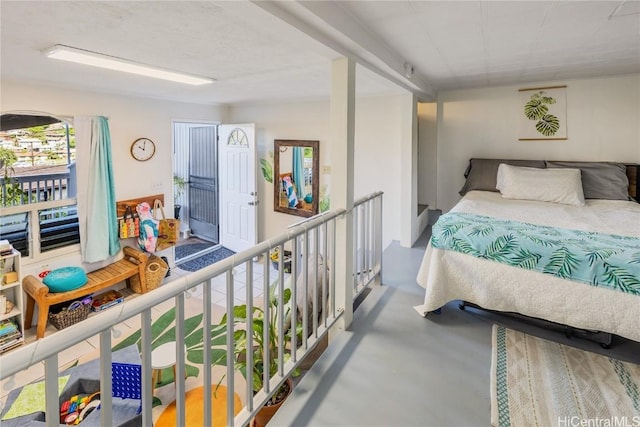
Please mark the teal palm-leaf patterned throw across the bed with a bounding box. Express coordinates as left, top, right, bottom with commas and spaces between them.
431, 212, 640, 295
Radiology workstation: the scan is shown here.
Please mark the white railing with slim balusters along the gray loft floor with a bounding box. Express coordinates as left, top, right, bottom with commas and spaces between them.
0, 193, 382, 426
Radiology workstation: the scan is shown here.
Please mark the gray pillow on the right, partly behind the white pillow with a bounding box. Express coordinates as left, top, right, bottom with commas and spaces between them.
546, 161, 629, 200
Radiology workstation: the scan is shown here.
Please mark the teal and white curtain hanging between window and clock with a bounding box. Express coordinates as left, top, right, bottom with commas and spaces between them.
82, 116, 120, 262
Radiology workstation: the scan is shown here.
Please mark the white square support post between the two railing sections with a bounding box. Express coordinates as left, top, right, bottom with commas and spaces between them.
330, 58, 356, 329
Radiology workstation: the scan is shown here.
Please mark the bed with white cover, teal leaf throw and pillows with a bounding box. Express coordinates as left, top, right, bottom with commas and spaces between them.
415, 159, 640, 346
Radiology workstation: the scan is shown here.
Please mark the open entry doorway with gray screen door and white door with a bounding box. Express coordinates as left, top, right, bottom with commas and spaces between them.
173, 122, 258, 261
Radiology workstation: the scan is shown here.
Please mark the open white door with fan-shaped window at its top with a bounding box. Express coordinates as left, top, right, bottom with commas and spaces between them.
218, 123, 258, 252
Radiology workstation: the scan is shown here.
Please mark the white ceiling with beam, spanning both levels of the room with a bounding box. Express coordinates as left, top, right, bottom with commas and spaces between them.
0, 0, 640, 104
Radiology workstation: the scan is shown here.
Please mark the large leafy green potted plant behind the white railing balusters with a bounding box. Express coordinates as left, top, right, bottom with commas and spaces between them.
220, 282, 302, 427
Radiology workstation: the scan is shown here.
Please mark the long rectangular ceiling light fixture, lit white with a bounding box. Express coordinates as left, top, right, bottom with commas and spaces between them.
43, 44, 215, 86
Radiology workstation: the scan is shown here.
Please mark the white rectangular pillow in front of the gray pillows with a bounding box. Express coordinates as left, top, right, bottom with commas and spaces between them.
496, 163, 584, 206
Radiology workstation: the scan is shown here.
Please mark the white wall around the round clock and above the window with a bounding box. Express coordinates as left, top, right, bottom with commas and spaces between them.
0, 80, 227, 268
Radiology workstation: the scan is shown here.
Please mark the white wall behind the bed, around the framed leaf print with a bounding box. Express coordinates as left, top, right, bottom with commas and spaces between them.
436, 74, 640, 211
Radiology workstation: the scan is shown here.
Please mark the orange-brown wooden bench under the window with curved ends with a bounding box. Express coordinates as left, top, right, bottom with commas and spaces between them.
22, 247, 147, 339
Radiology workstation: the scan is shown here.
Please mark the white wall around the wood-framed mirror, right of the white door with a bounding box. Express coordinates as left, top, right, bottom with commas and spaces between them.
229, 96, 401, 247
